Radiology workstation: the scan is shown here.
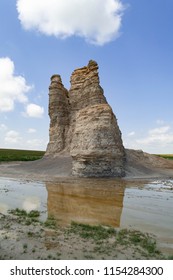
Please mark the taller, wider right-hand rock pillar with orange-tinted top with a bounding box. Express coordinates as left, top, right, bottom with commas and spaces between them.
69, 61, 125, 177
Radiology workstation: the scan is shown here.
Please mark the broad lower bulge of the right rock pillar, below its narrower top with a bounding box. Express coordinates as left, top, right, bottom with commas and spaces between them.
71, 104, 124, 176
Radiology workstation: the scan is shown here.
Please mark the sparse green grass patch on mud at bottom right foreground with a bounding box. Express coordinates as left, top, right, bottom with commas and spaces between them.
68, 222, 162, 257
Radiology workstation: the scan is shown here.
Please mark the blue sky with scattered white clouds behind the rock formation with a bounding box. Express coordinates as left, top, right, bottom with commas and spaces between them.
0, 0, 173, 153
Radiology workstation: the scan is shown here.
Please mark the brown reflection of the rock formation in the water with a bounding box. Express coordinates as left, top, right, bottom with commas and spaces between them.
46, 179, 125, 227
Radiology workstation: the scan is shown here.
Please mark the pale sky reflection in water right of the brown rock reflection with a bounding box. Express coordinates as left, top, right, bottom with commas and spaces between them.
121, 181, 173, 252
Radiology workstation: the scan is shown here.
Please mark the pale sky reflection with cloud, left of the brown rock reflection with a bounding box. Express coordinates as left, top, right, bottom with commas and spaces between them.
0, 178, 47, 221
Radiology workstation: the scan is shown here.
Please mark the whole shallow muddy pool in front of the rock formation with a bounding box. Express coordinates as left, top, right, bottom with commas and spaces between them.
0, 178, 173, 253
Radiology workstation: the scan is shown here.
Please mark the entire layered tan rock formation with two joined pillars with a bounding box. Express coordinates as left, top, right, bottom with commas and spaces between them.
46, 60, 125, 177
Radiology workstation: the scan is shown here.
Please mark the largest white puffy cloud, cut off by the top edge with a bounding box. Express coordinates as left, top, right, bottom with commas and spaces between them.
17, 0, 124, 45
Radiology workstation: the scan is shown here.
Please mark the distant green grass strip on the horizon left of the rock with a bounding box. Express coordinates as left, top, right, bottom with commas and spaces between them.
0, 149, 45, 161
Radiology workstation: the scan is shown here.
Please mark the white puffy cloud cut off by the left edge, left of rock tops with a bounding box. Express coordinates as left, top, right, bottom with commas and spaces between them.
0, 57, 32, 112
